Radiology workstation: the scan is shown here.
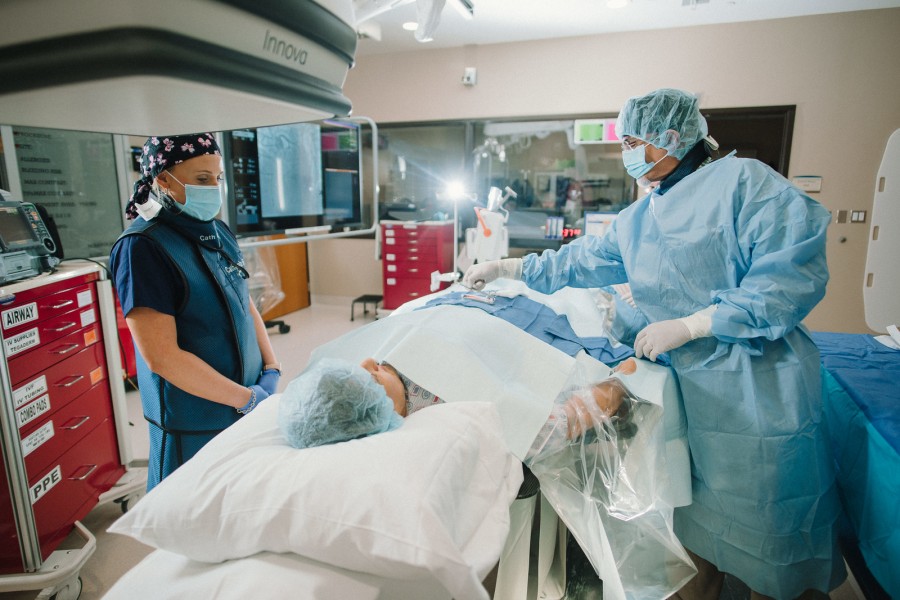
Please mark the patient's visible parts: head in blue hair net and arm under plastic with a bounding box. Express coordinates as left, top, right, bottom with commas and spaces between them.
279, 358, 637, 462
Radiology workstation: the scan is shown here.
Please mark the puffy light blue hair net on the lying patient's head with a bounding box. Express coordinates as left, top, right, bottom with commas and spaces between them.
278, 358, 403, 448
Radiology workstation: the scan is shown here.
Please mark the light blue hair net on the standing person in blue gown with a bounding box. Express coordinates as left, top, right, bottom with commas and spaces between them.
616, 88, 709, 160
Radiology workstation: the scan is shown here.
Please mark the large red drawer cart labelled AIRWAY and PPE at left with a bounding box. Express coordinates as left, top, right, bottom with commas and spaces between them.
0, 266, 130, 574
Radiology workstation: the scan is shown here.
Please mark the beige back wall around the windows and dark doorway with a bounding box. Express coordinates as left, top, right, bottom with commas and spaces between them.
310, 9, 900, 332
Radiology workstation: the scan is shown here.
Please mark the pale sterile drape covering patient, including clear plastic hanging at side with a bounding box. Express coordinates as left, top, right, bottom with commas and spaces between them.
310, 306, 695, 599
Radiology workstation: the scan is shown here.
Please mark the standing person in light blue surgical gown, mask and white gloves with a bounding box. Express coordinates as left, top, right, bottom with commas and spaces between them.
463, 89, 845, 598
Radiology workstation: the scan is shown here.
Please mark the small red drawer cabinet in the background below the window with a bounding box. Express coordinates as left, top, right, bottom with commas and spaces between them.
381, 221, 453, 310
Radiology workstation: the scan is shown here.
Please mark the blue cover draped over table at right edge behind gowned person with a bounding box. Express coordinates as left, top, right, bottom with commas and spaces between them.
813, 333, 900, 598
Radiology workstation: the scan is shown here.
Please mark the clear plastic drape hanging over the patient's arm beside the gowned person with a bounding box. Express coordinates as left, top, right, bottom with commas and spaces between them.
526, 358, 696, 600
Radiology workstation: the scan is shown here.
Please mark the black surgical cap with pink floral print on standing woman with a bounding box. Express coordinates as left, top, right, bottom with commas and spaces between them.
125, 133, 222, 219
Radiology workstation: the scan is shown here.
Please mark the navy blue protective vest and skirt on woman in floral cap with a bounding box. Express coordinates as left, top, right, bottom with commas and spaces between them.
120, 210, 263, 489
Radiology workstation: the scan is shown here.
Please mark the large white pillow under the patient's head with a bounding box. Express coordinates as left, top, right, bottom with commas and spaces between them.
109, 395, 522, 600
